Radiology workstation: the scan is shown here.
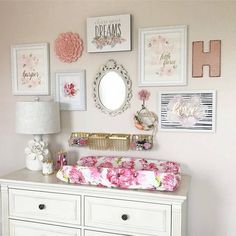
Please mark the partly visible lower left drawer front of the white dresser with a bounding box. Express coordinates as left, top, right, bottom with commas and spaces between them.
10, 220, 80, 236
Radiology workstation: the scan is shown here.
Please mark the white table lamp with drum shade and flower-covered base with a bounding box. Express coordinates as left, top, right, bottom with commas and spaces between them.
15, 99, 60, 171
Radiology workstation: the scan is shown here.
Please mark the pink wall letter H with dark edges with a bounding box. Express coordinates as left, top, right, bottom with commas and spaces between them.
192, 40, 221, 78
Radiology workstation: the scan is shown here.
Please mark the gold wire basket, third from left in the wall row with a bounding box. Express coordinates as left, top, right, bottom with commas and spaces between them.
109, 134, 130, 151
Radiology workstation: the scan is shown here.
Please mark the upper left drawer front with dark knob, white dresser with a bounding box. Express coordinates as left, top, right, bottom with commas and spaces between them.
9, 189, 81, 225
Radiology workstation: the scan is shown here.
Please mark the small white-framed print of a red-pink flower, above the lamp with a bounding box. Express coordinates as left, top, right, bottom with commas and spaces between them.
55, 70, 86, 111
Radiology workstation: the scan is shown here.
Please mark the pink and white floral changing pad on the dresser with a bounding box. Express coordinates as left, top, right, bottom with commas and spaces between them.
57, 156, 181, 191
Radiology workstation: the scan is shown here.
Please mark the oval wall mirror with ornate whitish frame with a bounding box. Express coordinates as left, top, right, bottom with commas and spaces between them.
93, 60, 132, 116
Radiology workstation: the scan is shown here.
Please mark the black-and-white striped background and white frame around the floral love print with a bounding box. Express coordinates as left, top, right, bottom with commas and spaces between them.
159, 91, 216, 132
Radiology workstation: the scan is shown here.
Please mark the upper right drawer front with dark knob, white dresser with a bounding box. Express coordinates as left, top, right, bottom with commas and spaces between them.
85, 196, 171, 236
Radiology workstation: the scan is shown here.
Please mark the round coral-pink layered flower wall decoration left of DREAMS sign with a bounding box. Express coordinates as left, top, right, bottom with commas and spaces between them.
54, 32, 83, 63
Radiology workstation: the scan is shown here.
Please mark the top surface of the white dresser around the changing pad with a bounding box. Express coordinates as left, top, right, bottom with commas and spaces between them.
0, 169, 191, 200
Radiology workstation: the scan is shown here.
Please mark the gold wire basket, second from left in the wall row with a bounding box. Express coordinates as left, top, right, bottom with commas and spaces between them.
89, 133, 109, 150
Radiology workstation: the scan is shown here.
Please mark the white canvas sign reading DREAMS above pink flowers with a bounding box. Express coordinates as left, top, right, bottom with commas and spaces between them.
87, 14, 131, 52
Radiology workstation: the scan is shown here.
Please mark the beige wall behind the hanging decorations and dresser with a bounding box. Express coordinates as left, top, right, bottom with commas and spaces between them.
0, 0, 236, 236
